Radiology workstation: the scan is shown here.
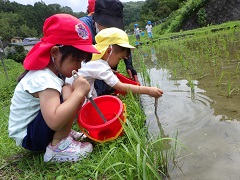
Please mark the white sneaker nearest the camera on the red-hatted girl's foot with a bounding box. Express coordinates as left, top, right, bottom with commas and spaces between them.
44, 136, 93, 162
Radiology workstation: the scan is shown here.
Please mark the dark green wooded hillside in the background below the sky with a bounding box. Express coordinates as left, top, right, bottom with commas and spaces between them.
0, 0, 188, 41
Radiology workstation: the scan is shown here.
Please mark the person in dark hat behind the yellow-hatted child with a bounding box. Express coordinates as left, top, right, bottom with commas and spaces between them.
80, 0, 138, 95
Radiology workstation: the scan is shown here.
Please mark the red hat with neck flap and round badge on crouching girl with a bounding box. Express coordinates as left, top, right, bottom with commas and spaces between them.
23, 14, 99, 70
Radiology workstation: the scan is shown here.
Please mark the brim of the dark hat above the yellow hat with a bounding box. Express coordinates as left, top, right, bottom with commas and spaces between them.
93, 12, 124, 30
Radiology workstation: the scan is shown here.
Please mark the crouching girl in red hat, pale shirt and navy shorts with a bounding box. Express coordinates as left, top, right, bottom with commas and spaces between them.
8, 14, 99, 162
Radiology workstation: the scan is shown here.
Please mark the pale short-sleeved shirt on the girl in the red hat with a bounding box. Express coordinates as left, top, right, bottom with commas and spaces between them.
8, 68, 64, 146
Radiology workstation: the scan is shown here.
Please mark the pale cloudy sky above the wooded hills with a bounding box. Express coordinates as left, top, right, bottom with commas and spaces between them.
10, 0, 143, 12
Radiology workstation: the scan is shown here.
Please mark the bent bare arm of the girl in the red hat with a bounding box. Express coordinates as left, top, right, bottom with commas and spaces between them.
38, 77, 90, 131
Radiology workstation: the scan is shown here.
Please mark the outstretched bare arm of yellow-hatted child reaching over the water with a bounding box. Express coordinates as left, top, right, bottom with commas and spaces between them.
113, 81, 163, 98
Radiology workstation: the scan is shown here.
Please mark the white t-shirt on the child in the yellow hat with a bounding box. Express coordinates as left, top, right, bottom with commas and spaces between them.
65, 59, 119, 97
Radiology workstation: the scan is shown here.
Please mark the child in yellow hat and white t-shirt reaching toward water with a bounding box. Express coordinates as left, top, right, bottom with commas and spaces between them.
67, 28, 163, 98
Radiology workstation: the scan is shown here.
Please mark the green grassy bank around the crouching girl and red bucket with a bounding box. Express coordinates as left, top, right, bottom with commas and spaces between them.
0, 60, 180, 180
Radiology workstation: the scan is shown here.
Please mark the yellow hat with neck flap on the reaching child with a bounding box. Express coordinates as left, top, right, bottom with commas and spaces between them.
92, 27, 135, 60
